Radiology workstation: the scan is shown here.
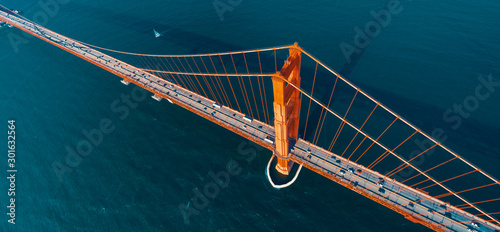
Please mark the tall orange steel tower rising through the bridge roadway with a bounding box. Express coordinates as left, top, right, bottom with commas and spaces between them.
272, 43, 302, 175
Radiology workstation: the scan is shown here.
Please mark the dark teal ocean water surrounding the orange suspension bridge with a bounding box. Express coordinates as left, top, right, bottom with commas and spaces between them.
0, 0, 500, 232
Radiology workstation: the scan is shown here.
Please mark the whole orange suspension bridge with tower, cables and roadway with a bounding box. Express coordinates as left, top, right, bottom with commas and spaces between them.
0, 6, 500, 232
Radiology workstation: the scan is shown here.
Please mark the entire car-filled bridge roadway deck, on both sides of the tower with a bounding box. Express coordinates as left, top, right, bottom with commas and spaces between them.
0, 9, 500, 232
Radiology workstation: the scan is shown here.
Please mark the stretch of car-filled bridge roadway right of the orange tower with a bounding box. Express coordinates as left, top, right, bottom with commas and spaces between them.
292, 139, 499, 232
